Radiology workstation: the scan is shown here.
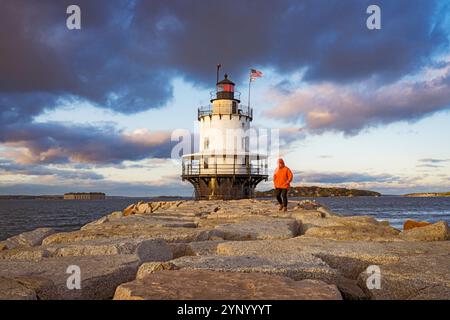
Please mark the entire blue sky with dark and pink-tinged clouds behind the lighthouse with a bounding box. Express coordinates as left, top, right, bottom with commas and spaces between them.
0, 0, 450, 196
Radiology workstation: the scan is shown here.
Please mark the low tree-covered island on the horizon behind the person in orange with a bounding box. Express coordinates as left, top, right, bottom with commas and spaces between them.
256, 186, 381, 198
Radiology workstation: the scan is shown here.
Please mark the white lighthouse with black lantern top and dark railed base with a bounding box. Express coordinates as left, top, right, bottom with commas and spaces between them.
181, 69, 268, 200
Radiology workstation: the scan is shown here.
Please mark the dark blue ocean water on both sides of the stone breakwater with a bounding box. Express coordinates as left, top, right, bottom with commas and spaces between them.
0, 196, 450, 240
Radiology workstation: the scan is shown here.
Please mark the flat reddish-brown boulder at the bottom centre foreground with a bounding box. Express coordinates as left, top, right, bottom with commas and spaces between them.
114, 270, 342, 300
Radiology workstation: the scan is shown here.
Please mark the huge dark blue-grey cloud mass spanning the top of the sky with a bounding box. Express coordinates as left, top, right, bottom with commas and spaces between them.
0, 0, 448, 122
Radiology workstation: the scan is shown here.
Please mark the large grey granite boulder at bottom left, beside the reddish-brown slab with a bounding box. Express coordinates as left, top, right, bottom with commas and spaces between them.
0, 255, 141, 299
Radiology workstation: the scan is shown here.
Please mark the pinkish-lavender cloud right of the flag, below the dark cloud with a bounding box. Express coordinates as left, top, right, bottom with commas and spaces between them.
265, 67, 450, 134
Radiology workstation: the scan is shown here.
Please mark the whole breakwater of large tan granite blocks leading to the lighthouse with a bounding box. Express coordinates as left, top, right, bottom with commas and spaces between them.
0, 200, 450, 299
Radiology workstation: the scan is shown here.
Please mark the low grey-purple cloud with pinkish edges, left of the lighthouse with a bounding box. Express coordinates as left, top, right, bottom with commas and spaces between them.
0, 122, 172, 164
